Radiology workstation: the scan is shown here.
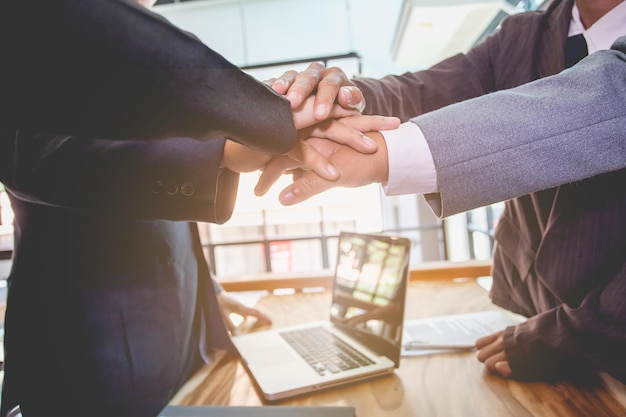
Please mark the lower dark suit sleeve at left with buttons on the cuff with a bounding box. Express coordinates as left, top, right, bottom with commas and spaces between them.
2, 132, 239, 223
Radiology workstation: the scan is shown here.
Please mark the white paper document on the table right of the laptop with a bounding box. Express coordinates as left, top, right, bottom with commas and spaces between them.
402, 310, 525, 356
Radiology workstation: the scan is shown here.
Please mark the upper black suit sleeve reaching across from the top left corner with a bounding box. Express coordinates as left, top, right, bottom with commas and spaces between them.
0, 0, 296, 153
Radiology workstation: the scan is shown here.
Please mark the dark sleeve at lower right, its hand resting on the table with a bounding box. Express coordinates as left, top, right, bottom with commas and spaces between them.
504, 264, 626, 381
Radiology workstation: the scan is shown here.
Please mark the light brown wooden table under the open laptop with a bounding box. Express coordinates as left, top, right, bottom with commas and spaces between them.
171, 279, 626, 417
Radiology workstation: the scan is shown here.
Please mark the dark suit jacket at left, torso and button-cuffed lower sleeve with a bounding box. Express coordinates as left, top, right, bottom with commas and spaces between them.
2, 134, 238, 416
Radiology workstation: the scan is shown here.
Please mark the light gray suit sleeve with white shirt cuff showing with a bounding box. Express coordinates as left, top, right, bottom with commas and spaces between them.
412, 37, 626, 216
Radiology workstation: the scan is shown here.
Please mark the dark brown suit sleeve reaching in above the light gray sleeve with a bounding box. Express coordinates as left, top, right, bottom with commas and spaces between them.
353, 7, 543, 122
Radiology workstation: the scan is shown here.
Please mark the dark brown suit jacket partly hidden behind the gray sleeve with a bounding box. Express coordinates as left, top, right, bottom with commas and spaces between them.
355, 0, 626, 379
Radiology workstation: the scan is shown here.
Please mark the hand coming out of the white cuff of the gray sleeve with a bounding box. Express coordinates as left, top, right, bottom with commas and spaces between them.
254, 128, 388, 205
